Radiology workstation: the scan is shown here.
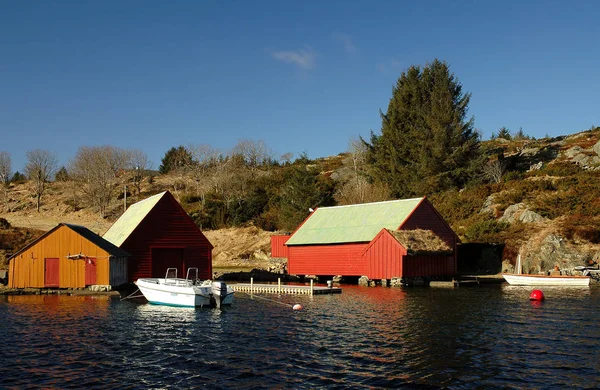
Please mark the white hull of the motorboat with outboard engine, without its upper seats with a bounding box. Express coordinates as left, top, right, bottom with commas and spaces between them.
135, 278, 233, 307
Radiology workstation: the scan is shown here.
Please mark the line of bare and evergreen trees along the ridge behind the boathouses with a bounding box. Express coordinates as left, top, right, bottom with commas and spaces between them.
0, 59, 527, 230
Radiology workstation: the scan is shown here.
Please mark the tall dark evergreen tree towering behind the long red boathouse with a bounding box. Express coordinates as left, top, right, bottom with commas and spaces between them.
365, 59, 482, 197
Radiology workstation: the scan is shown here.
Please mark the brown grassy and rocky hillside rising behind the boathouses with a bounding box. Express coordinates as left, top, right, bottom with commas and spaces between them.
0, 128, 600, 272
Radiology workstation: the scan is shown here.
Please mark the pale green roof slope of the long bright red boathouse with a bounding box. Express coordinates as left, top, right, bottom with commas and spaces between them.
286, 198, 423, 245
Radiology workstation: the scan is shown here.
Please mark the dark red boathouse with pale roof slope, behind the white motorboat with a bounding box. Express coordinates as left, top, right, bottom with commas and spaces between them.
103, 191, 213, 282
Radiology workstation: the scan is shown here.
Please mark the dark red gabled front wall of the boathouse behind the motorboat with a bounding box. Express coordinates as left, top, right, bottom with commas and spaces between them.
121, 193, 212, 282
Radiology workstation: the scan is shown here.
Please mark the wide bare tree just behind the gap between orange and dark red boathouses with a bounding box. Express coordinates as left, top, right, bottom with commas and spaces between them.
69, 145, 129, 218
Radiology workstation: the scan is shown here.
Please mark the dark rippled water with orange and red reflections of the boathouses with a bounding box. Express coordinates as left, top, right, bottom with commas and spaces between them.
0, 286, 600, 389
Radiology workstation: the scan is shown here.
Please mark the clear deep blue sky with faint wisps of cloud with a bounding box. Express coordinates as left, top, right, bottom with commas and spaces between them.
0, 0, 600, 171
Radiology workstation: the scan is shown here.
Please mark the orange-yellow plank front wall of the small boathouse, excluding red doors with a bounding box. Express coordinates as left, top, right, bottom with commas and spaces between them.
8, 226, 118, 288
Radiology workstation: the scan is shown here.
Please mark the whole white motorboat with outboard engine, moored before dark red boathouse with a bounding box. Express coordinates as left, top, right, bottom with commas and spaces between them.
135, 268, 234, 308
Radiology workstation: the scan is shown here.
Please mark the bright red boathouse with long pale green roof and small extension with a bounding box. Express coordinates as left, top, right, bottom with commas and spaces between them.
285, 198, 459, 279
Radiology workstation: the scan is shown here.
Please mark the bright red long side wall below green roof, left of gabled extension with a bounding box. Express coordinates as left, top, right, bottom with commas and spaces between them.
288, 243, 367, 276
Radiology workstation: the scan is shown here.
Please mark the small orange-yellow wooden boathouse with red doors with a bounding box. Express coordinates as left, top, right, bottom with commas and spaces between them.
8, 224, 127, 288
